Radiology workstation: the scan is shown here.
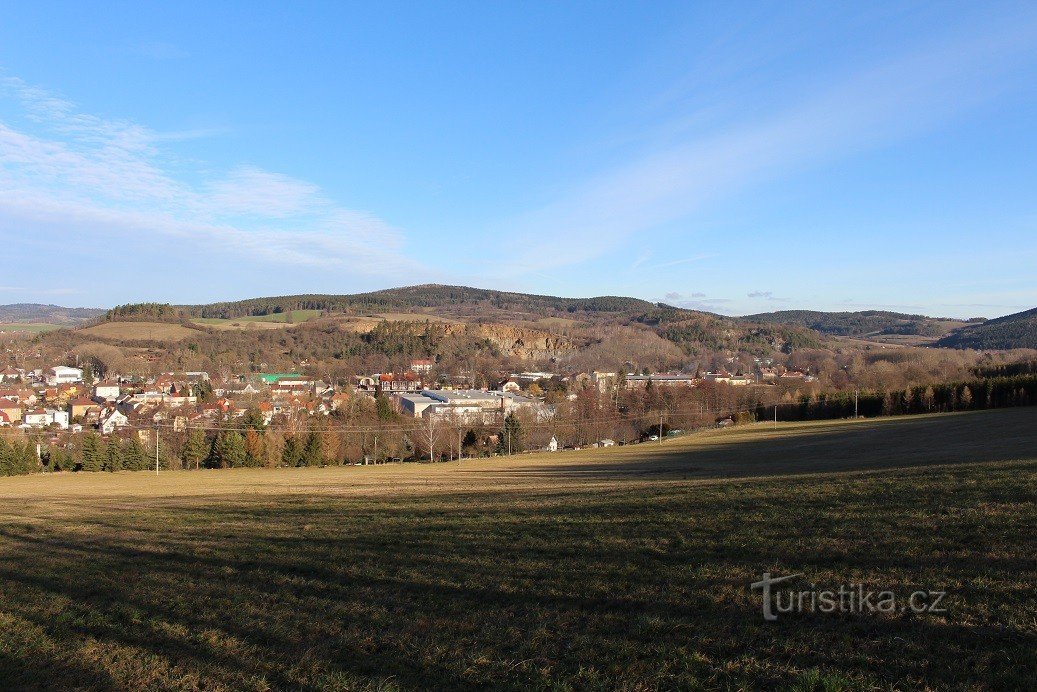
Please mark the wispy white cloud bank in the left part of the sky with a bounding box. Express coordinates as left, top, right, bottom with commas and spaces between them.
0, 77, 420, 275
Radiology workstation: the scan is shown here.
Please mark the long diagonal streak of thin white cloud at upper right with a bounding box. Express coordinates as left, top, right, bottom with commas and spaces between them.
491, 12, 1037, 267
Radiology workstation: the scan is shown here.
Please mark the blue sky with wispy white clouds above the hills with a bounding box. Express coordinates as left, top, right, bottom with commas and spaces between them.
0, 1, 1037, 317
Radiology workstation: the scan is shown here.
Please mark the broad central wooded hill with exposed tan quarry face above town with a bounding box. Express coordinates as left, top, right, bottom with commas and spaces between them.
75, 284, 820, 369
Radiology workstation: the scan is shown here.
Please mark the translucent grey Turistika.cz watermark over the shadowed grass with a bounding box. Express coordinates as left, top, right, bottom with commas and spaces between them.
750, 572, 947, 621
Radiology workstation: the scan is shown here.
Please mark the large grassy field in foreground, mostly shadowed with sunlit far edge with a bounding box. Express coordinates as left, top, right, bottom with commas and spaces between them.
0, 409, 1037, 690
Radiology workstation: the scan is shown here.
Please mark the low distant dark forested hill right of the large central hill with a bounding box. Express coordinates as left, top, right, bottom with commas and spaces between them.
742, 310, 970, 337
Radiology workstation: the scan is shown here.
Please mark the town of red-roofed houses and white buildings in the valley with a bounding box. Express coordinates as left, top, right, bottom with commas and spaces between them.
0, 359, 814, 444
